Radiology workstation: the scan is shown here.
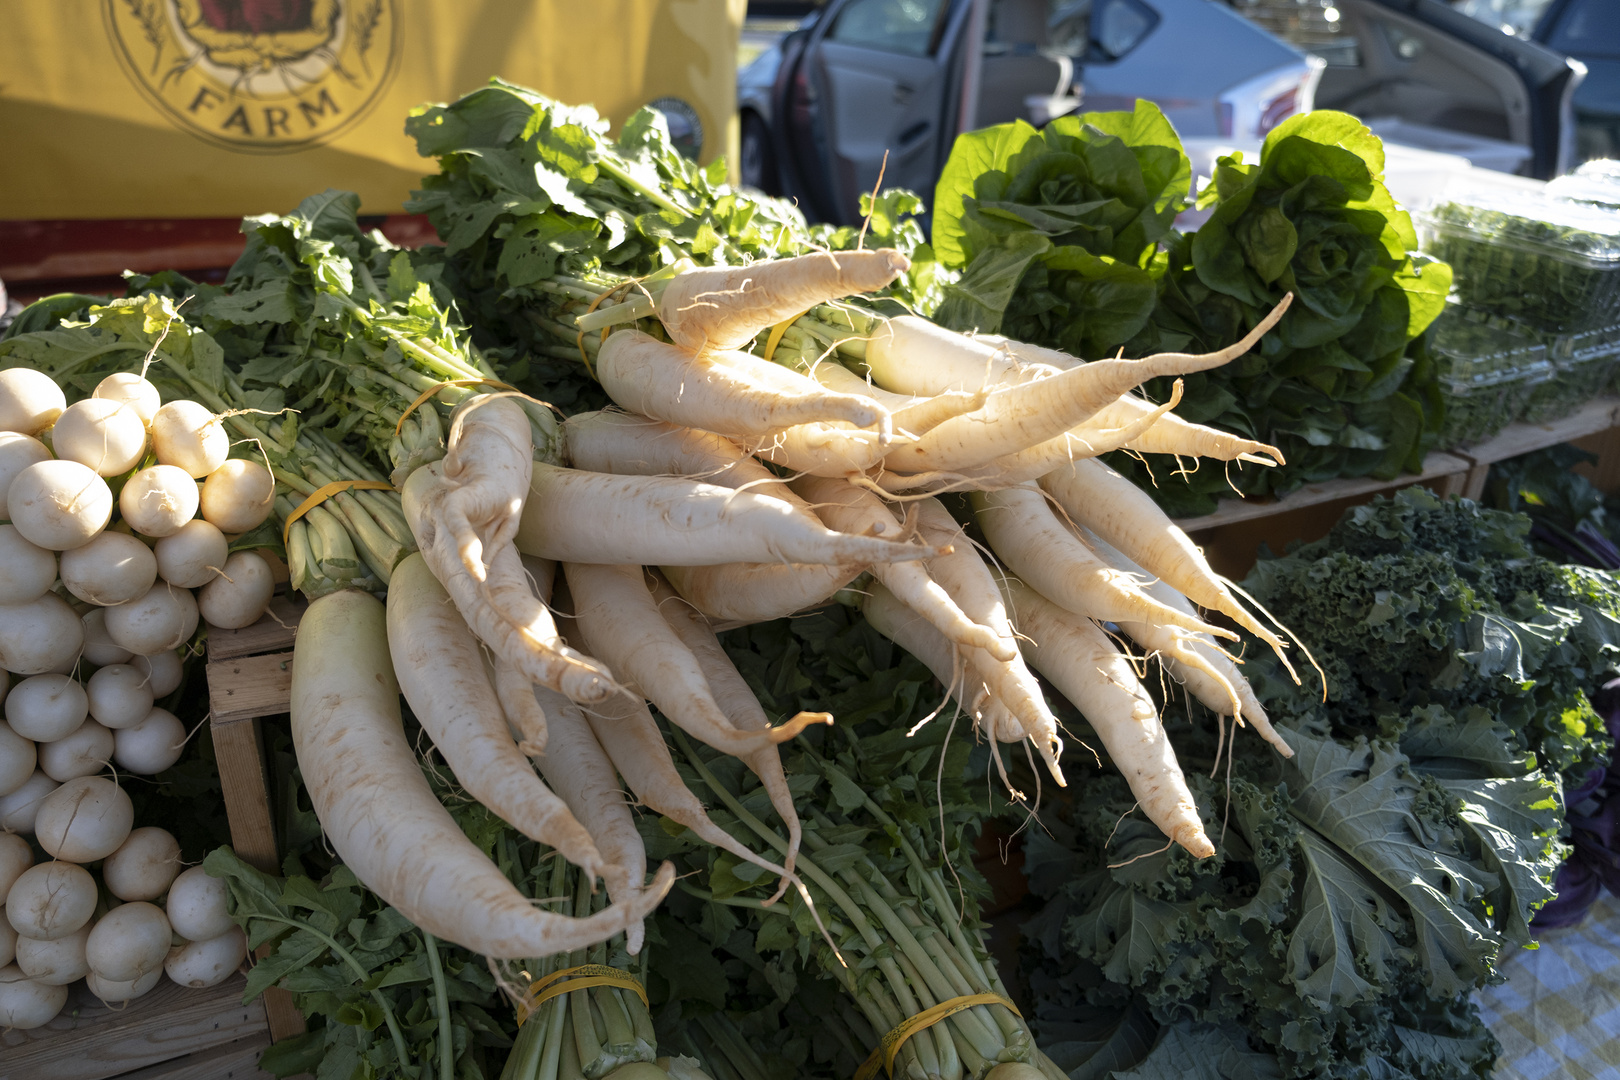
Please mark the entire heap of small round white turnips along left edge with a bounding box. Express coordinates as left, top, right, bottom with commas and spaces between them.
0, 368, 274, 1027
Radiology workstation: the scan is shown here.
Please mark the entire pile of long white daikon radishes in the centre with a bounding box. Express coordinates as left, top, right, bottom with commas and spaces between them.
301, 249, 1288, 959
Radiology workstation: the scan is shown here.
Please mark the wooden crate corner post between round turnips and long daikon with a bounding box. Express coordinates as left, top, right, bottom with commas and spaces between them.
204, 596, 308, 1049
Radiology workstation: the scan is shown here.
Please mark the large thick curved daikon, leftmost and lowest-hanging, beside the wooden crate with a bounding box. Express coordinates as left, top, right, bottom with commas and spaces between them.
292, 591, 674, 960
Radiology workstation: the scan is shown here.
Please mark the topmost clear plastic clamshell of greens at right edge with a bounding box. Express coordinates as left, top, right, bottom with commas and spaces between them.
1418, 191, 1620, 334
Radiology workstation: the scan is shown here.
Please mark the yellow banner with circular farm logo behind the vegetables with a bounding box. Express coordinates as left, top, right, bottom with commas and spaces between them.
0, 0, 747, 220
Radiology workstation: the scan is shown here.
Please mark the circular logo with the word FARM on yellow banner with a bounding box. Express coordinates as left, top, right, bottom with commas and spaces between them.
105, 0, 400, 154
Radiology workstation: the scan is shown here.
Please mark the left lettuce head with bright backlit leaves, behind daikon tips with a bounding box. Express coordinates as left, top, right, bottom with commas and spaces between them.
933, 100, 1192, 359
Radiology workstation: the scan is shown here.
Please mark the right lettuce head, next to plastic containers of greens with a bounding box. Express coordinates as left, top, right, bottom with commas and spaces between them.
1115, 110, 1452, 517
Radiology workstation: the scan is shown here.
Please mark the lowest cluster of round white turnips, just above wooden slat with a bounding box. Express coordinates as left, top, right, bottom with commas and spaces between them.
0, 816, 248, 1030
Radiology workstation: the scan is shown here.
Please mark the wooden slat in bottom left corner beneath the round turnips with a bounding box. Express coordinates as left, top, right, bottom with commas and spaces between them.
0, 975, 269, 1080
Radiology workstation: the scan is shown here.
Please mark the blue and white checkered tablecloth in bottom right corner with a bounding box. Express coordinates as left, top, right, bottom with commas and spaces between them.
1476, 892, 1620, 1080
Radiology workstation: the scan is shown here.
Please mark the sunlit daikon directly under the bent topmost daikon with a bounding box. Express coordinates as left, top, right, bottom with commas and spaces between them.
596, 330, 891, 439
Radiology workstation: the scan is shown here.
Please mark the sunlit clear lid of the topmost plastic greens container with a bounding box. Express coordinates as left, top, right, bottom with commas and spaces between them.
1422, 191, 1620, 267
